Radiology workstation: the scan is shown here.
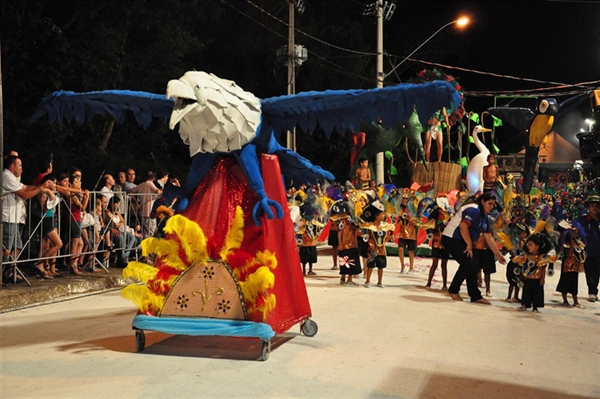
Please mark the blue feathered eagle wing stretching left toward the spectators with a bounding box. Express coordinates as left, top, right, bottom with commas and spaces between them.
31, 90, 173, 129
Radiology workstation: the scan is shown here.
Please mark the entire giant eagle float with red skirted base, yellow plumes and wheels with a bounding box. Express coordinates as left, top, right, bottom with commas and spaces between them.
33, 71, 460, 346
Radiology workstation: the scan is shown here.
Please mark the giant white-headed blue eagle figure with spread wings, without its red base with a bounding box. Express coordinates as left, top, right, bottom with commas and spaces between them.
32, 71, 460, 225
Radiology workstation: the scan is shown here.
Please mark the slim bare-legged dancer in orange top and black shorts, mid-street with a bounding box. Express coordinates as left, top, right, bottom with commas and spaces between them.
394, 188, 417, 274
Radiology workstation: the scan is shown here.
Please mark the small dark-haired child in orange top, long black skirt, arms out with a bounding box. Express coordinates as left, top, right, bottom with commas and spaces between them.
513, 233, 556, 313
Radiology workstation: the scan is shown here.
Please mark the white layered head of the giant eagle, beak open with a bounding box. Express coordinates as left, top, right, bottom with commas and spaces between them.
167, 71, 261, 156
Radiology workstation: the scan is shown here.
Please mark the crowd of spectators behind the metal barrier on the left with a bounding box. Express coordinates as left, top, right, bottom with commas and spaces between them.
2, 151, 179, 285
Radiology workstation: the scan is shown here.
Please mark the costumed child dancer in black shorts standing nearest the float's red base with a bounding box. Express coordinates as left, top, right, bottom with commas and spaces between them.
296, 188, 324, 276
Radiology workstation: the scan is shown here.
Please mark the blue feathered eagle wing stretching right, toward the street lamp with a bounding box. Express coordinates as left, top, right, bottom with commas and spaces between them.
261, 81, 461, 137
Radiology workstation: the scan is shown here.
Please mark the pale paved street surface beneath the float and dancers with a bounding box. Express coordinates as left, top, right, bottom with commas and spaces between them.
0, 252, 600, 399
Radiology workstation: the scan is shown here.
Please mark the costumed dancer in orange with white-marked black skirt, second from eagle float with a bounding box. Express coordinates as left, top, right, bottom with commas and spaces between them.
329, 200, 362, 285
